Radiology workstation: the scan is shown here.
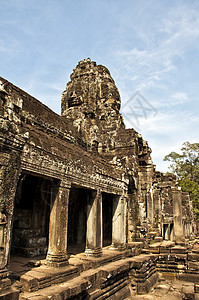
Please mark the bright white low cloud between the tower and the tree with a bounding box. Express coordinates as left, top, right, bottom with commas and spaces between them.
124, 102, 199, 172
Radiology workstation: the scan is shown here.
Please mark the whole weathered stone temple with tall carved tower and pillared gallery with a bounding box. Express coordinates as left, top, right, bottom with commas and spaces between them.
0, 59, 199, 300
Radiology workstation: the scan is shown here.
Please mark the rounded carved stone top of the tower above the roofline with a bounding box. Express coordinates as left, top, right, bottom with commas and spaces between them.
62, 60, 121, 114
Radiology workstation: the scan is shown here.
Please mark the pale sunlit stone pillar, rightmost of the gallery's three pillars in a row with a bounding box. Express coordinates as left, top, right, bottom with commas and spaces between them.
110, 196, 126, 250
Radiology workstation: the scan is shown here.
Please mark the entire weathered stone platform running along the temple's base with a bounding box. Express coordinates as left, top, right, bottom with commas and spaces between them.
4, 241, 199, 300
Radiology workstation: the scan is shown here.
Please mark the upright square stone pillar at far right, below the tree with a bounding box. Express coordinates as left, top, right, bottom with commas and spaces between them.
172, 188, 184, 243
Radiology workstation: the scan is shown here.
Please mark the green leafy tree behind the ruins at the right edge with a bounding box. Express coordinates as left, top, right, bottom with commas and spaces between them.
164, 142, 199, 219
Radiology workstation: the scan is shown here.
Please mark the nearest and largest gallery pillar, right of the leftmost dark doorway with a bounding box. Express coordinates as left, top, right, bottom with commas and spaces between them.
46, 182, 70, 267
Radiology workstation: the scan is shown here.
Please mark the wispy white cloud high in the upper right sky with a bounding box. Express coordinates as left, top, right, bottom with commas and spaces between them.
116, 5, 199, 91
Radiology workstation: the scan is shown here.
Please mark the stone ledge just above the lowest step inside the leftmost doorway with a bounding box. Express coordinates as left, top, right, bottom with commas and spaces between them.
14, 236, 47, 248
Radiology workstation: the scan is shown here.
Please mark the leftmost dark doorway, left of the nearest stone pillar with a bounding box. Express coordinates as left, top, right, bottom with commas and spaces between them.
11, 173, 59, 258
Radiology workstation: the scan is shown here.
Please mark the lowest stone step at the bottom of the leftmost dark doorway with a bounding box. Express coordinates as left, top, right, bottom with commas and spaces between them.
13, 246, 47, 257
